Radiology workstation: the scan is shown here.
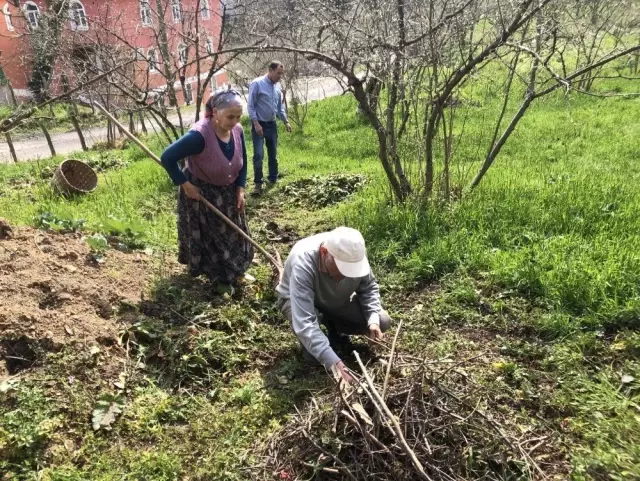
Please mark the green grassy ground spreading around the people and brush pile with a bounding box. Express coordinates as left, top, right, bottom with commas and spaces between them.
0, 84, 640, 480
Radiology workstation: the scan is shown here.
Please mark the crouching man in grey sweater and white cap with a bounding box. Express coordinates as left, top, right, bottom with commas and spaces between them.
276, 227, 391, 382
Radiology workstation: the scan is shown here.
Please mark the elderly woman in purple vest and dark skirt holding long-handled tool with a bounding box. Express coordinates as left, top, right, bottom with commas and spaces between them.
161, 90, 253, 285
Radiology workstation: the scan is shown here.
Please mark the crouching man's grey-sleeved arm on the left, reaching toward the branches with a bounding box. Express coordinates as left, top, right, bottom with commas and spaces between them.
289, 264, 340, 369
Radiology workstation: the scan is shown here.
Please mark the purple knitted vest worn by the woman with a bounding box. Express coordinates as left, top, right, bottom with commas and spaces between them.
187, 118, 243, 186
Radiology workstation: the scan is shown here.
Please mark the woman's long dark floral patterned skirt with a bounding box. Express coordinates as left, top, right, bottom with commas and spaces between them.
178, 169, 253, 284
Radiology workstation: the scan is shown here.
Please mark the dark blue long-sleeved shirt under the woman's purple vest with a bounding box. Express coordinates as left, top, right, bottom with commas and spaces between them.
160, 130, 247, 187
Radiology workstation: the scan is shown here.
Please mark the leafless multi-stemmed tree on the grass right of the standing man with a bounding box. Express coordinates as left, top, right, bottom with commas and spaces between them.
226, 0, 640, 200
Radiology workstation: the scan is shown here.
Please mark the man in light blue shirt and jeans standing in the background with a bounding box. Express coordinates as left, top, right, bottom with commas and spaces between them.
247, 60, 291, 195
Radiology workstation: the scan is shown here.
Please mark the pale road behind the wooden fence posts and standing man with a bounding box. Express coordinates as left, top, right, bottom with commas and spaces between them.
0, 77, 342, 164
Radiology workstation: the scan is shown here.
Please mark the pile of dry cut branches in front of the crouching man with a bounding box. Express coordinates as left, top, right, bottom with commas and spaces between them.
259, 324, 560, 481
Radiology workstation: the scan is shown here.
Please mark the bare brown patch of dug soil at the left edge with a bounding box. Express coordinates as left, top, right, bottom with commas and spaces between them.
0, 228, 175, 377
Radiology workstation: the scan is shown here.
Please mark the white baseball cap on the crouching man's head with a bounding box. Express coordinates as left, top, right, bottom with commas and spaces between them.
325, 227, 371, 278
